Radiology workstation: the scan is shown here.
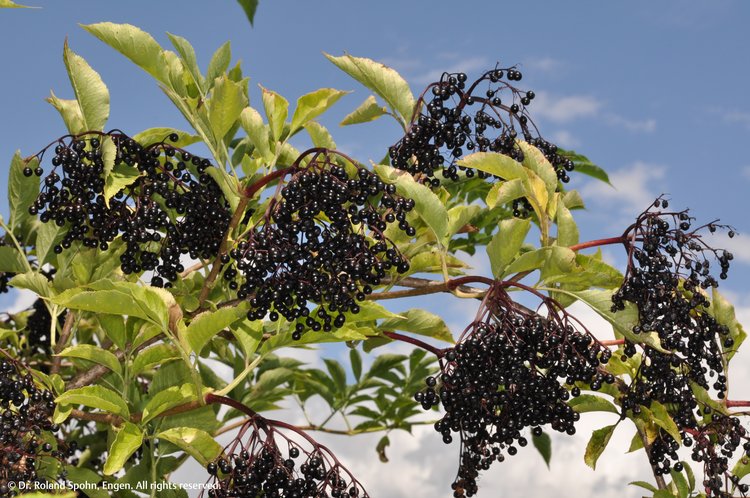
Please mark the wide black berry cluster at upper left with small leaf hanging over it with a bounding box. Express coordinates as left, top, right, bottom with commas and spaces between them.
24, 131, 230, 286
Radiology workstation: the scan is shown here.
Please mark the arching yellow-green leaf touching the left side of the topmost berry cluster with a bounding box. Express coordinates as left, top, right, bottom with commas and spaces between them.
324, 54, 415, 126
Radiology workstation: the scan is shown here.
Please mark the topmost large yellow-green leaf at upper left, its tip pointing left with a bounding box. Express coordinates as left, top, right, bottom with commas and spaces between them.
83, 22, 169, 84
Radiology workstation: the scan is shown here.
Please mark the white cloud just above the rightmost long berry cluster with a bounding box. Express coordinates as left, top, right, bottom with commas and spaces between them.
580, 161, 666, 215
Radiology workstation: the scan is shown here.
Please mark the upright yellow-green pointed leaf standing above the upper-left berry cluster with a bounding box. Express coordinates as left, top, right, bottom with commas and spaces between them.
63, 40, 109, 131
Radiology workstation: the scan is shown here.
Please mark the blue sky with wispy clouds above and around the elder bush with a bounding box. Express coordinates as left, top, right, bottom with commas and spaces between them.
0, 0, 750, 496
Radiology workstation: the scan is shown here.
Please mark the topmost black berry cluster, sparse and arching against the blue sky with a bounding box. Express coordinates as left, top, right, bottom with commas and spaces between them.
390, 67, 573, 186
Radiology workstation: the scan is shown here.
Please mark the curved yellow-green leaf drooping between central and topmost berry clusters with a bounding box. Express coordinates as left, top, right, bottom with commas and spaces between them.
375, 164, 448, 243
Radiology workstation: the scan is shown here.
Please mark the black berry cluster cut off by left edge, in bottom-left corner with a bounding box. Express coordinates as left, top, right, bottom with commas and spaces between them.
0, 359, 75, 497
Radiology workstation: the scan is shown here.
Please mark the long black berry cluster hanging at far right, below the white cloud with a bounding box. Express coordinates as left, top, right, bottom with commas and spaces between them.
612, 198, 733, 416
